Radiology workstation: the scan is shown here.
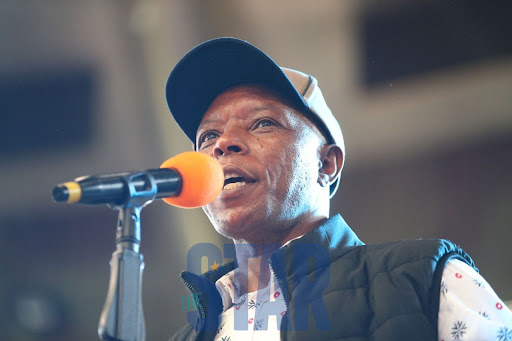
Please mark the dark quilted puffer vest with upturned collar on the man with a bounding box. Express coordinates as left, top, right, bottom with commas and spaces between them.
171, 215, 474, 341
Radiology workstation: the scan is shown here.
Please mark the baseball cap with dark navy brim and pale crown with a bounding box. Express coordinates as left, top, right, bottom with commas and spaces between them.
166, 37, 345, 197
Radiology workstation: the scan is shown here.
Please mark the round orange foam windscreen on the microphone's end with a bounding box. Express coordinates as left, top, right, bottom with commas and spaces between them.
160, 152, 224, 208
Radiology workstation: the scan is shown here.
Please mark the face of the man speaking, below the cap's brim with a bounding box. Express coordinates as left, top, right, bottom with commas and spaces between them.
196, 86, 328, 243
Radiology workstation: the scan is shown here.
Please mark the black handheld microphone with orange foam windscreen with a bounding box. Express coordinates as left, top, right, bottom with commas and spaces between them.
52, 152, 224, 208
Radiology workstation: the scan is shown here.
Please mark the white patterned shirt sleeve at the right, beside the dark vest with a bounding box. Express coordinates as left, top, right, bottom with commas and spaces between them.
438, 259, 512, 341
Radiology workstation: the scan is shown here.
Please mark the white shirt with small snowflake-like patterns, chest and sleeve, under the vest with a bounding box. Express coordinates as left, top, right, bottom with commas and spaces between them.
215, 259, 512, 341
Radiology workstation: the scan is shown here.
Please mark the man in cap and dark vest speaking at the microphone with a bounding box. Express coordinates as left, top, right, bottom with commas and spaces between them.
166, 38, 512, 341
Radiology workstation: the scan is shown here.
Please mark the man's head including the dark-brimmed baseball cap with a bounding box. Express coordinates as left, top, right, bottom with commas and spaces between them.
167, 38, 344, 239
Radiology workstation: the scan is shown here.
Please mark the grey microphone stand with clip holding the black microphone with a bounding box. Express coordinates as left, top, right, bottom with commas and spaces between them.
98, 172, 157, 341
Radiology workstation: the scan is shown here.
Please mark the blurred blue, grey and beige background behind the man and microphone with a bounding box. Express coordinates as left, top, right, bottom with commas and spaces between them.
0, 0, 512, 341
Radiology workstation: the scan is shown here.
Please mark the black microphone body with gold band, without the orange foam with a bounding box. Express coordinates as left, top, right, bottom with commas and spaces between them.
52, 168, 182, 205
